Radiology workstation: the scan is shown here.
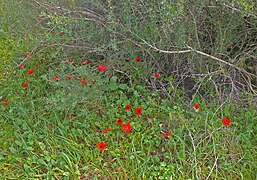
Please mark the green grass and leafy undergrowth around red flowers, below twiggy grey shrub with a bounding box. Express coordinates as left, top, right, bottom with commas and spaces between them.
0, 1, 257, 180
